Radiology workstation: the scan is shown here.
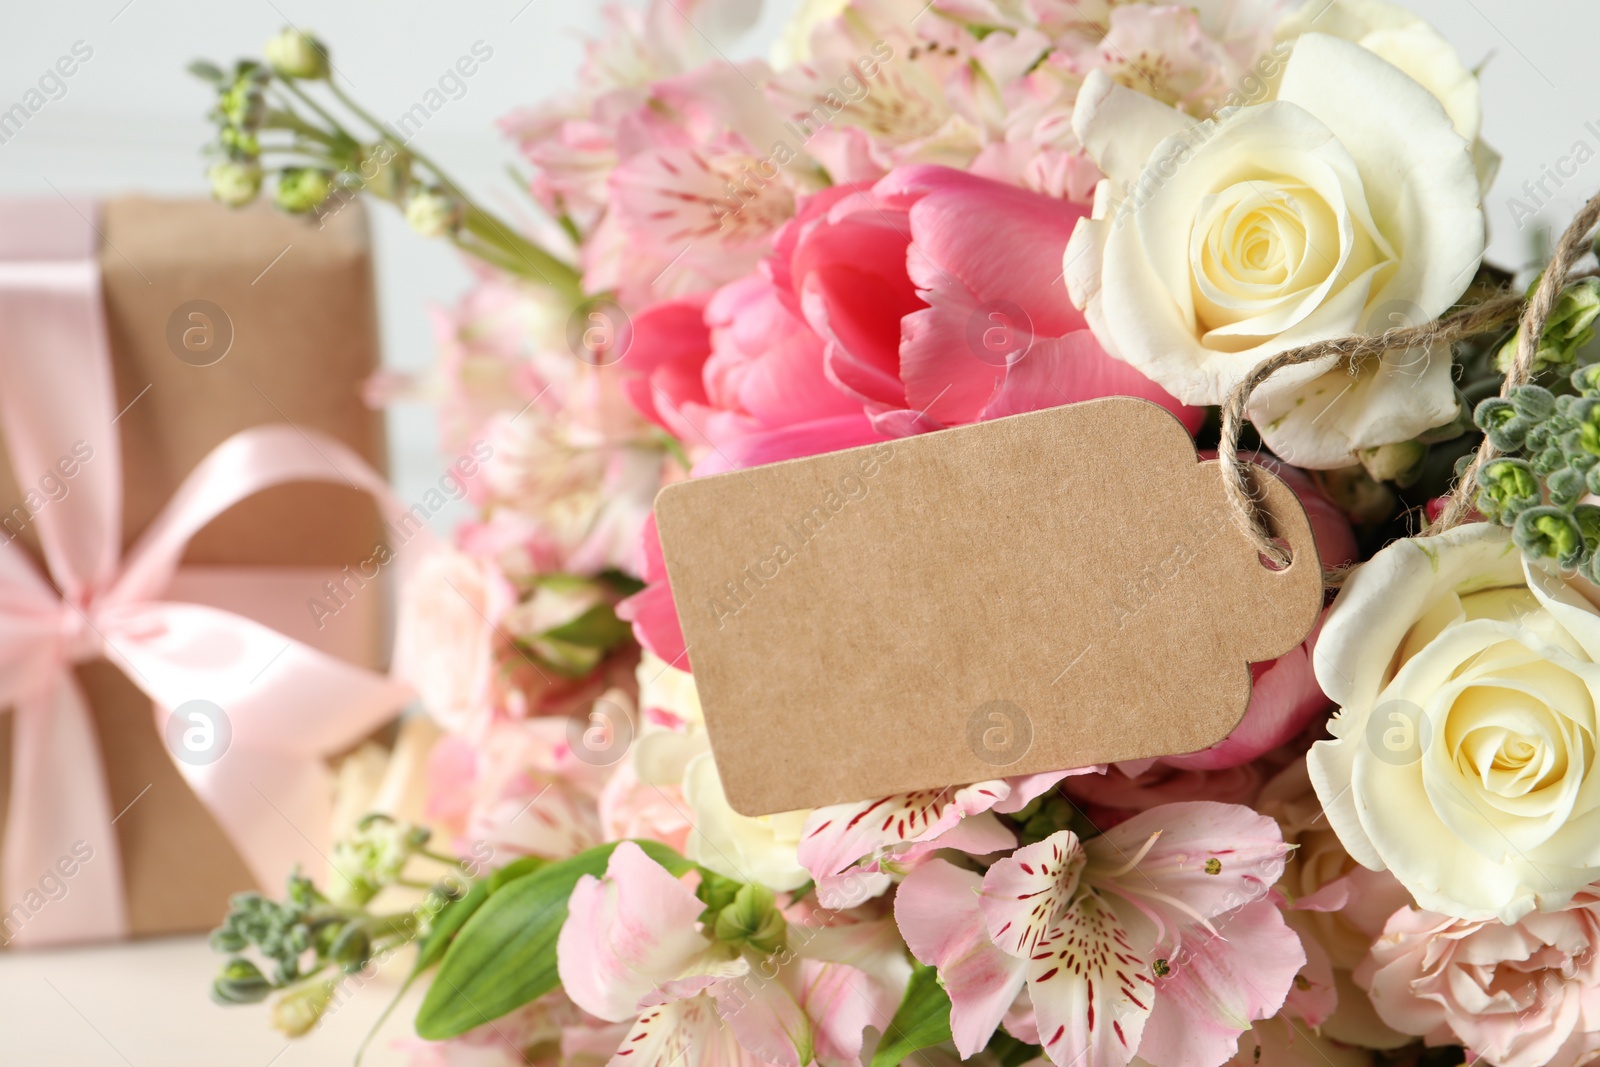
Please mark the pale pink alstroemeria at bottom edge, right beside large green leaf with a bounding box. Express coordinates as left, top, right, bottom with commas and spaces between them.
555, 841, 909, 1067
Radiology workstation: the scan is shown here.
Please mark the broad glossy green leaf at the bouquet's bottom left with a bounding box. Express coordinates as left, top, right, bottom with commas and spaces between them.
416, 841, 691, 1041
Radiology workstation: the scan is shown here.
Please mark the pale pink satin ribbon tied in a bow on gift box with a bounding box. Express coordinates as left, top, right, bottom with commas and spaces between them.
0, 200, 426, 945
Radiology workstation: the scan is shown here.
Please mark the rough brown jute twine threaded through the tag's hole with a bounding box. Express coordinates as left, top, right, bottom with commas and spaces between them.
1218, 185, 1600, 585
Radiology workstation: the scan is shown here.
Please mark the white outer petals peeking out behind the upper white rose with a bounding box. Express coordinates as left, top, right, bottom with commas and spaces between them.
1275, 0, 1499, 192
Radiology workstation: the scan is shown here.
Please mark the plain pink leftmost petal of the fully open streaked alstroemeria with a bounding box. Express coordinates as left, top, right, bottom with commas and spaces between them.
894, 859, 1027, 1057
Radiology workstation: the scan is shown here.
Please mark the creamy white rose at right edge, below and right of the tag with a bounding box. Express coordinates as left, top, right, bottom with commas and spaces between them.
1307, 523, 1600, 923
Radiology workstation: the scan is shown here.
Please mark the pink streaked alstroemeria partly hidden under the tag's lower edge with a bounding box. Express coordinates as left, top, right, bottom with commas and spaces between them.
798, 768, 1104, 907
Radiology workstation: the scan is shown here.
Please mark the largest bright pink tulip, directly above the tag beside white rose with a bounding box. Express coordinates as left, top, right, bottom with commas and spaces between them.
793, 166, 1203, 435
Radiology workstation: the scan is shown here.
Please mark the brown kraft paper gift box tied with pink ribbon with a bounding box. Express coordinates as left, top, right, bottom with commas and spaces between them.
0, 197, 396, 942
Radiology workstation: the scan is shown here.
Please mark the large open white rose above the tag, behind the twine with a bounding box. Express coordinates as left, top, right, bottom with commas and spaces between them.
1066, 34, 1485, 469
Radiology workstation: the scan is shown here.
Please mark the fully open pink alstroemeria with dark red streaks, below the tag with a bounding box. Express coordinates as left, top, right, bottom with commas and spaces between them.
894, 801, 1306, 1067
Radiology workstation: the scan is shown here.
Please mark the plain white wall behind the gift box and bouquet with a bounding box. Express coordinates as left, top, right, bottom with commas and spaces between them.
0, 0, 1600, 515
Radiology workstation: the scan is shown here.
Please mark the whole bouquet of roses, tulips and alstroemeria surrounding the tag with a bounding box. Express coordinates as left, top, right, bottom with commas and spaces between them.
195, 0, 1600, 1067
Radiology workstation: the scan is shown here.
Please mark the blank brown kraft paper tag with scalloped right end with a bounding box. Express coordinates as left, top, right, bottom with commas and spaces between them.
656, 397, 1322, 816
